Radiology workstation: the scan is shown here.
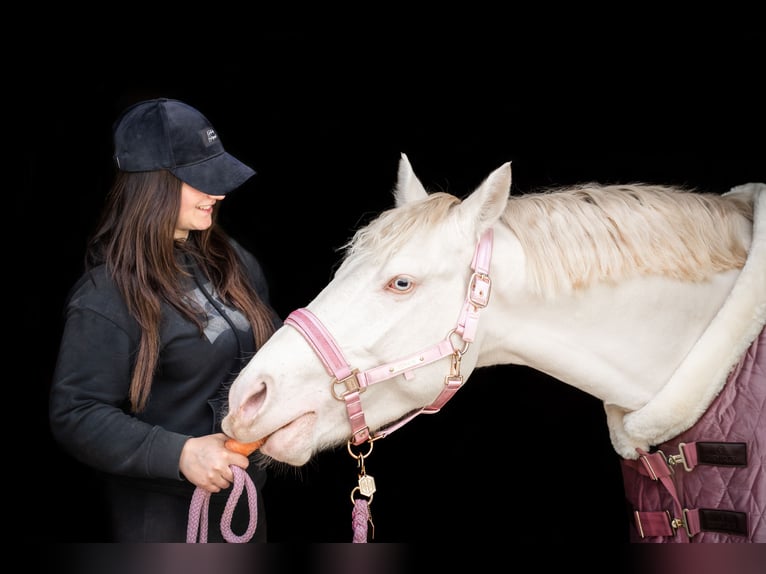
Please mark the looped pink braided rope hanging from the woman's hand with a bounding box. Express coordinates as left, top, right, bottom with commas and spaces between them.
186, 465, 258, 544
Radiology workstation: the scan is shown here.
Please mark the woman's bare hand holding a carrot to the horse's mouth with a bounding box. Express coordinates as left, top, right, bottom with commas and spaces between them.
178, 433, 250, 493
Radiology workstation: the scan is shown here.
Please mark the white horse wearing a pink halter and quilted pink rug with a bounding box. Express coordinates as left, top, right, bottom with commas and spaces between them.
224, 155, 766, 542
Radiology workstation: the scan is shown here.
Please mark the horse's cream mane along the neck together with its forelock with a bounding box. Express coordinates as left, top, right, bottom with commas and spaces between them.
343, 183, 753, 297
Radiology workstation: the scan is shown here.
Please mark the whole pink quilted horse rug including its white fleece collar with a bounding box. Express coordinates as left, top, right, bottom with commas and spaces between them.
605, 183, 766, 543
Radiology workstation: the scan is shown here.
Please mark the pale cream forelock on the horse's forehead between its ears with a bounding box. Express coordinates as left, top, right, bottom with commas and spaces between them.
342, 192, 460, 262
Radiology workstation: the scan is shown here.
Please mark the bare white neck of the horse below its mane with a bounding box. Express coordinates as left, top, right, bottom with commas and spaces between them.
476, 228, 737, 410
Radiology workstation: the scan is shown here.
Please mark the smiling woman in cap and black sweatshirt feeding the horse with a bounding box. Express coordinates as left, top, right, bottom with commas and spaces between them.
49, 98, 280, 542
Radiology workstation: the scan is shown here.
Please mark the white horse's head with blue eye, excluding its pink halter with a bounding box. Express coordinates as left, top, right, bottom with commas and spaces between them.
223, 154, 512, 466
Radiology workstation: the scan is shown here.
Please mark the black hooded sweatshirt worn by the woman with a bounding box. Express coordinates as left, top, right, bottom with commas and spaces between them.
49, 241, 280, 493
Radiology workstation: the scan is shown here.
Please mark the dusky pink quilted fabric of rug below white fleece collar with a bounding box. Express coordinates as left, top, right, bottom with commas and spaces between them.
622, 329, 766, 543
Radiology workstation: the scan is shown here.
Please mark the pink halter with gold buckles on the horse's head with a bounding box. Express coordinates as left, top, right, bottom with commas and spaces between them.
285, 228, 493, 445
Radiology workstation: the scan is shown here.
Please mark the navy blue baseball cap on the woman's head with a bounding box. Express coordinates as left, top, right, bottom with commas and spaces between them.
114, 98, 255, 195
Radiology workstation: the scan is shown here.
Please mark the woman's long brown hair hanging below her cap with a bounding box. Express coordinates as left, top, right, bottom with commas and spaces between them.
85, 170, 274, 412
